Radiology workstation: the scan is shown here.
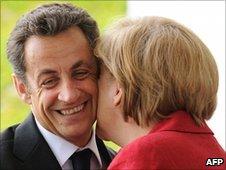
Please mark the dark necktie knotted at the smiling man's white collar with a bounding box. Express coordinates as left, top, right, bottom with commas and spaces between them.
70, 149, 92, 170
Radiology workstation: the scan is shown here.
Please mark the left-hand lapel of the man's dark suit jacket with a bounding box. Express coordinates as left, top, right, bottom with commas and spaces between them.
13, 115, 61, 170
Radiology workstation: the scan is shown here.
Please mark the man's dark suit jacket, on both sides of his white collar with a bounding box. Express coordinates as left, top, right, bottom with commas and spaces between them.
0, 114, 114, 170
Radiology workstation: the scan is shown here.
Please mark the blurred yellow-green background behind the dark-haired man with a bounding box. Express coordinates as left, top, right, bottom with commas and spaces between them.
0, 1, 126, 149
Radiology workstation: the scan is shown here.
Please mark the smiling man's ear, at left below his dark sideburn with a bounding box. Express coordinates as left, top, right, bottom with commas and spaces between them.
12, 74, 31, 105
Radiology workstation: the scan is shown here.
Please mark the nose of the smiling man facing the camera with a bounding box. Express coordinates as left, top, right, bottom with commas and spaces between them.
58, 81, 81, 103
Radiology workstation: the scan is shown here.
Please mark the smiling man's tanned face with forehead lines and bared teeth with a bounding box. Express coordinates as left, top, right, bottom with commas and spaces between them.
17, 27, 98, 146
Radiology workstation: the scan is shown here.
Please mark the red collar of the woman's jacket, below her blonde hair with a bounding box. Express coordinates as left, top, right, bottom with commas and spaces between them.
150, 111, 213, 135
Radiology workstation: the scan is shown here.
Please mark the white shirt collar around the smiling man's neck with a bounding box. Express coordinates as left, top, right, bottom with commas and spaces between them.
35, 119, 102, 167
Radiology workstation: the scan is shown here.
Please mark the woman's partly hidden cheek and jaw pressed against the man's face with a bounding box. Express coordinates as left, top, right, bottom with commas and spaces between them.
96, 66, 119, 140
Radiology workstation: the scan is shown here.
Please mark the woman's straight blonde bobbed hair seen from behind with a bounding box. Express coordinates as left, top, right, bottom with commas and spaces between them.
95, 17, 218, 126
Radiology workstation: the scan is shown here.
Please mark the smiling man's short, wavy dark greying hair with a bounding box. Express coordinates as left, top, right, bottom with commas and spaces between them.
7, 3, 99, 82
